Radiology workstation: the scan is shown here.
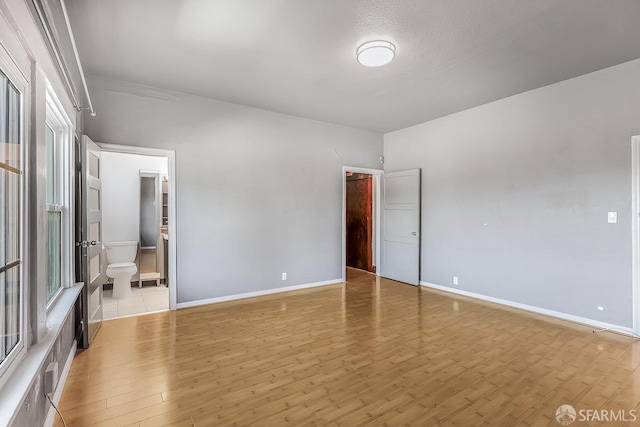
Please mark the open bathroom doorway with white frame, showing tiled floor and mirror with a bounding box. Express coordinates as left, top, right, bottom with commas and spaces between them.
98, 143, 177, 320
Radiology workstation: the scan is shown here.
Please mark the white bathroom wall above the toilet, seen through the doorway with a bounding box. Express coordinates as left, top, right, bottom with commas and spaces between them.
101, 152, 169, 242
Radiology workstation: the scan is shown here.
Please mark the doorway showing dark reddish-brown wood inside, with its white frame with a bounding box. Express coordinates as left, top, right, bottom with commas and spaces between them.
342, 166, 383, 280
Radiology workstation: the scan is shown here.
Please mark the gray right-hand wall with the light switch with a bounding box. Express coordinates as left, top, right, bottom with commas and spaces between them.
384, 60, 640, 327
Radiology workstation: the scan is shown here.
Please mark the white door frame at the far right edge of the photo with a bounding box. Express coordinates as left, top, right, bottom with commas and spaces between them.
631, 135, 640, 335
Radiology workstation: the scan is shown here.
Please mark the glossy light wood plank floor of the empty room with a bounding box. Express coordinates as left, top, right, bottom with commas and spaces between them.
56, 272, 640, 427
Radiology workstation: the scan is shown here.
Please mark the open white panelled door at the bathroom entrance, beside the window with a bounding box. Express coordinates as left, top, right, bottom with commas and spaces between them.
80, 135, 106, 345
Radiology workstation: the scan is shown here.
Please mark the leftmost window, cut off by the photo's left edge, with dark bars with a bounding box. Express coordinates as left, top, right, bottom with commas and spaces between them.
0, 70, 23, 365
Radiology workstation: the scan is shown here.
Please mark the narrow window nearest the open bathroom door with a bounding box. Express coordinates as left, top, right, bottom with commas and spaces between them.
45, 86, 71, 306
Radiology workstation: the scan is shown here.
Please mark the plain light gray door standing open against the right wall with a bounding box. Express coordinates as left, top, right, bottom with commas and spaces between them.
380, 169, 420, 285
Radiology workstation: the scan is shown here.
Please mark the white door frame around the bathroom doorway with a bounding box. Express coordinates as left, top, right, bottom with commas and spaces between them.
96, 142, 178, 310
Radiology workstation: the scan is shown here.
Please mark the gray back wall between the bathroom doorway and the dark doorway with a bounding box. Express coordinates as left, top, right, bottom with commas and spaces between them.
84, 79, 382, 302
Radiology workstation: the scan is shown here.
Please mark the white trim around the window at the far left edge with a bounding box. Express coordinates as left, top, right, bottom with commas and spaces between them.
0, 39, 31, 389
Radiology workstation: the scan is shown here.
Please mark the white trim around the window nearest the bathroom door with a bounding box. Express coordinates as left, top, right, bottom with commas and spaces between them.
43, 80, 74, 314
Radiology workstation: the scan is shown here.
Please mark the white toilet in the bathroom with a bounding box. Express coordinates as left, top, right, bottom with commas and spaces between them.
104, 241, 138, 299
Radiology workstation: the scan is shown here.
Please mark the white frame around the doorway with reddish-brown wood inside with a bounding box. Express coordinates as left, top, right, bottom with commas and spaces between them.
342, 166, 384, 282
